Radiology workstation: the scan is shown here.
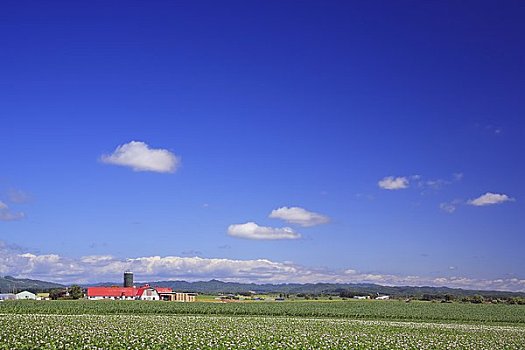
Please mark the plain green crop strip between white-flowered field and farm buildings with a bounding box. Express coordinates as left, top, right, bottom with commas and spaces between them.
0, 300, 525, 324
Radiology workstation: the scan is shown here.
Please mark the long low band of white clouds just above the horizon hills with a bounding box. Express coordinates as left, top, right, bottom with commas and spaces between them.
0, 241, 525, 292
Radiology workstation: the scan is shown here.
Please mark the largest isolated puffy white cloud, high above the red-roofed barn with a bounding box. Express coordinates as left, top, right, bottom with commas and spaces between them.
100, 141, 180, 173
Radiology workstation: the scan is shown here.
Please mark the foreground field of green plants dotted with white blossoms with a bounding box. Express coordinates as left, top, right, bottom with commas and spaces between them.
0, 314, 525, 349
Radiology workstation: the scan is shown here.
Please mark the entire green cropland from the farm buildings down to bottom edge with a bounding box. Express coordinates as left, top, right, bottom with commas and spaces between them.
0, 301, 525, 350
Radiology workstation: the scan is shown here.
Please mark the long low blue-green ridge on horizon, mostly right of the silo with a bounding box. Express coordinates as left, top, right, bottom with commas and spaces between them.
88, 280, 525, 298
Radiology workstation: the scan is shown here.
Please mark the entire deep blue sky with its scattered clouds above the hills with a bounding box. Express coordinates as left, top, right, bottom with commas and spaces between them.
0, 1, 525, 290
